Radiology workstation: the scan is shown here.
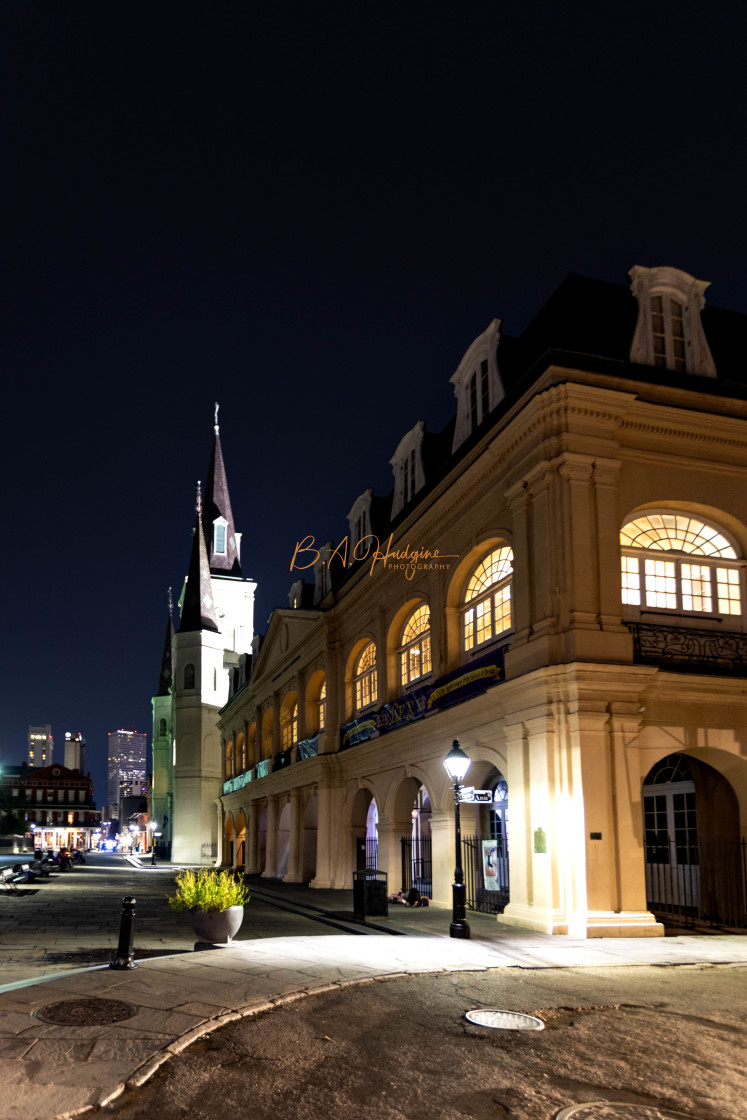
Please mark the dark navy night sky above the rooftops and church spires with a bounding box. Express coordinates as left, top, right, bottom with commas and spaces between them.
0, 0, 747, 805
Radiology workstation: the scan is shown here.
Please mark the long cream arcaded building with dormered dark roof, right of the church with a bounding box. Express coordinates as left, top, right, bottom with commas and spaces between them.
212, 267, 747, 936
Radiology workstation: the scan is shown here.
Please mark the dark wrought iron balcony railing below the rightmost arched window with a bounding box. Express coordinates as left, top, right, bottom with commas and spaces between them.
625, 623, 747, 676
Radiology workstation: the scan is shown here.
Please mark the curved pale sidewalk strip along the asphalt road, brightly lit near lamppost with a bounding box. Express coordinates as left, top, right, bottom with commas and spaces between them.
0, 881, 747, 1120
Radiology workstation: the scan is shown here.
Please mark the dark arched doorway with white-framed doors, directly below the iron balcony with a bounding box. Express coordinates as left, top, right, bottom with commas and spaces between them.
642, 753, 747, 928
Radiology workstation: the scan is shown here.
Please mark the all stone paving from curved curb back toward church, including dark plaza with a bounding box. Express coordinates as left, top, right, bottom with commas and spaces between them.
0, 857, 747, 1120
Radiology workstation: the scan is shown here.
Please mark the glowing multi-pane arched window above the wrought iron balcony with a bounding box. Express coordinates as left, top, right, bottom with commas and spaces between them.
620, 512, 741, 616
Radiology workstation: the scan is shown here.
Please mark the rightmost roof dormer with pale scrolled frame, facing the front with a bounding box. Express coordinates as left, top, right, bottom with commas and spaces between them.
628, 264, 716, 377
